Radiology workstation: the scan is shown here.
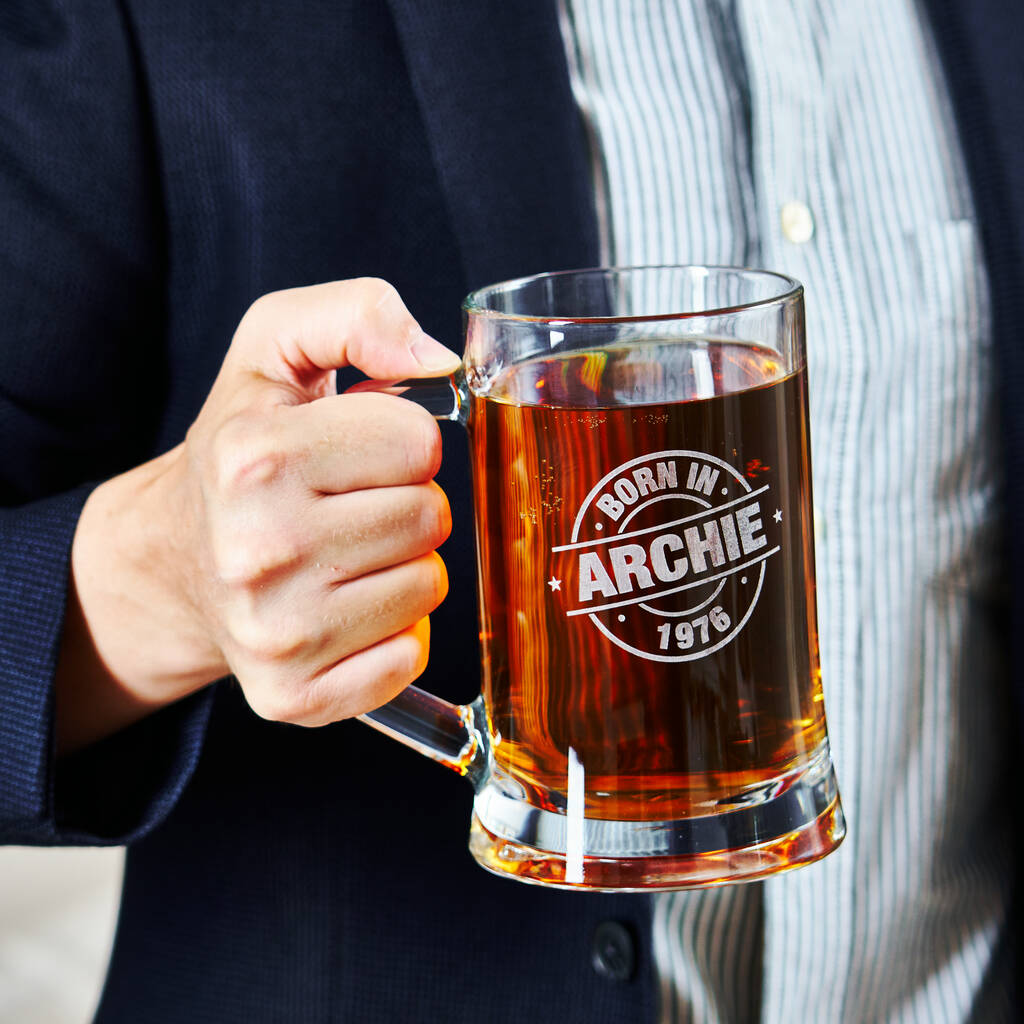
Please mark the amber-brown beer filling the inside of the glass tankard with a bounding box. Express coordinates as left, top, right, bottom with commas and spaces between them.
470, 338, 826, 884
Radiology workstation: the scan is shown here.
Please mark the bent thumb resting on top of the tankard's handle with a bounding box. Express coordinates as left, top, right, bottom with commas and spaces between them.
225, 278, 461, 390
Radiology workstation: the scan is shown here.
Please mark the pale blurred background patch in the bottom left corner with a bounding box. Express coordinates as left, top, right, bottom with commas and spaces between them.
0, 847, 124, 1024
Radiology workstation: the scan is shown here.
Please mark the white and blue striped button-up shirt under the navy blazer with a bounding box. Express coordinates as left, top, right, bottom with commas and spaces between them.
562, 0, 1012, 1024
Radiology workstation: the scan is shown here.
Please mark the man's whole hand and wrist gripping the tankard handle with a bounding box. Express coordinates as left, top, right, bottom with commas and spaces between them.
51, 279, 459, 751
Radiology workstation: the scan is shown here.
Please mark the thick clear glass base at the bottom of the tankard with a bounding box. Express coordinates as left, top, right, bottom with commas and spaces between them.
469, 745, 846, 892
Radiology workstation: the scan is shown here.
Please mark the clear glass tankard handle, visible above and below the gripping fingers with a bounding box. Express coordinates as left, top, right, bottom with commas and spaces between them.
346, 368, 490, 788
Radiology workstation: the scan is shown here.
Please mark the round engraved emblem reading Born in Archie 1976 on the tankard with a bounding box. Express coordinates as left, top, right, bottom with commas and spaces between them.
548, 451, 784, 662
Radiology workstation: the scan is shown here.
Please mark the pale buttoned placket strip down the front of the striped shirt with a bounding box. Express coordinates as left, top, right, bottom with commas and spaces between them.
738, 0, 866, 1020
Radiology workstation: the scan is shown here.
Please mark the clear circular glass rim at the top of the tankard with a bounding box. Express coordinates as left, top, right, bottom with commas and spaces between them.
462, 263, 804, 327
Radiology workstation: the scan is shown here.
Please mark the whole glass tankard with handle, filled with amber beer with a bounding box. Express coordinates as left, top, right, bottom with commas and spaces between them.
362, 266, 846, 890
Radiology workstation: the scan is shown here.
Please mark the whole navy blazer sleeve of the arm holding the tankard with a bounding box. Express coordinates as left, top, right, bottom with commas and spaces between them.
0, 0, 210, 843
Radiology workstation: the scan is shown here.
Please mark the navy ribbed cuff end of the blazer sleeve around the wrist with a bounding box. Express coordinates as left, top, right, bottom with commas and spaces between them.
0, 486, 214, 845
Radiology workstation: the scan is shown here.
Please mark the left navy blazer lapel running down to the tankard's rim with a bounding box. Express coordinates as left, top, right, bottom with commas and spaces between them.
391, 0, 598, 288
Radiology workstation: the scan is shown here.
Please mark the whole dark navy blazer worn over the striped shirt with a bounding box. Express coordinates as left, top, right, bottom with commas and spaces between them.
0, 0, 1024, 1024
